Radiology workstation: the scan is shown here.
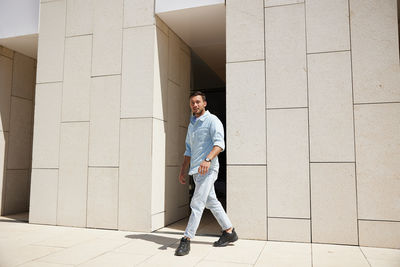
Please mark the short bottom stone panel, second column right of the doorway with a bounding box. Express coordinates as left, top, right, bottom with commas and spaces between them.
268, 218, 311, 242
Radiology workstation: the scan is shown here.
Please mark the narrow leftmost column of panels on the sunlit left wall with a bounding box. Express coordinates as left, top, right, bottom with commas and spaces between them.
29, 0, 67, 224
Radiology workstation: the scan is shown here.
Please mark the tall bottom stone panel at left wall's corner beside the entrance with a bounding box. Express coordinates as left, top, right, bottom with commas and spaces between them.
118, 118, 153, 232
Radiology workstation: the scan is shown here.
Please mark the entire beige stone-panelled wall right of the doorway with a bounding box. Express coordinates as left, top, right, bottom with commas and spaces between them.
226, 0, 400, 248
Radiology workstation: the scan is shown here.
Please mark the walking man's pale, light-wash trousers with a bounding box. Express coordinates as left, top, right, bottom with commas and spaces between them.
185, 170, 232, 239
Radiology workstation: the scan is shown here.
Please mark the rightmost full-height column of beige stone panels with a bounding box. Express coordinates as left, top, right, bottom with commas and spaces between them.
349, 0, 400, 248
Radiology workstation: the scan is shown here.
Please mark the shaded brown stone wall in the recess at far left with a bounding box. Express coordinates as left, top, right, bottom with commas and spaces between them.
0, 46, 36, 218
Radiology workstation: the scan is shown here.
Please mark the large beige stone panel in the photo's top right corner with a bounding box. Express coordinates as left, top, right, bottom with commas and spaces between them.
350, 0, 400, 103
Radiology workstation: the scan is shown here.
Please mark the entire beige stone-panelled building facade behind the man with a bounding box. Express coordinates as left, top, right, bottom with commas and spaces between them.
0, 0, 400, 251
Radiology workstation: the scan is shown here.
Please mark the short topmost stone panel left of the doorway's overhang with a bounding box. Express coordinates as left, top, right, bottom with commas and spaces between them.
124, 0, 156, 28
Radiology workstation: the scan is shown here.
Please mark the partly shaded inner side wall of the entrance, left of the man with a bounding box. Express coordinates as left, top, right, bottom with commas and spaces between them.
152, 18, 191, 230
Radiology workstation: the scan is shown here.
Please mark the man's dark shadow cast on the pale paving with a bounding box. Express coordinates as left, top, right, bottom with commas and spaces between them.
125, 232, 217, 250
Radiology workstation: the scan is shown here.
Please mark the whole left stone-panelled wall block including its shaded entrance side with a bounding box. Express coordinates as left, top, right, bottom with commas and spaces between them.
29, 0, 190, 231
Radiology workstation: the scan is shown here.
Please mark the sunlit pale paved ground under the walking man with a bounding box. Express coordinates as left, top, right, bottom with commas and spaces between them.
0, 214, 400, 267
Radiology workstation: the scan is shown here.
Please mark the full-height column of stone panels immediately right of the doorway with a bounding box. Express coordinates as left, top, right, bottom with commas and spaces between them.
226, 0, 267, 240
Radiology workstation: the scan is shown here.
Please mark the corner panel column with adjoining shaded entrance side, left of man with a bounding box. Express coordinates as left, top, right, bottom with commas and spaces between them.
118, 1, 190, 231
